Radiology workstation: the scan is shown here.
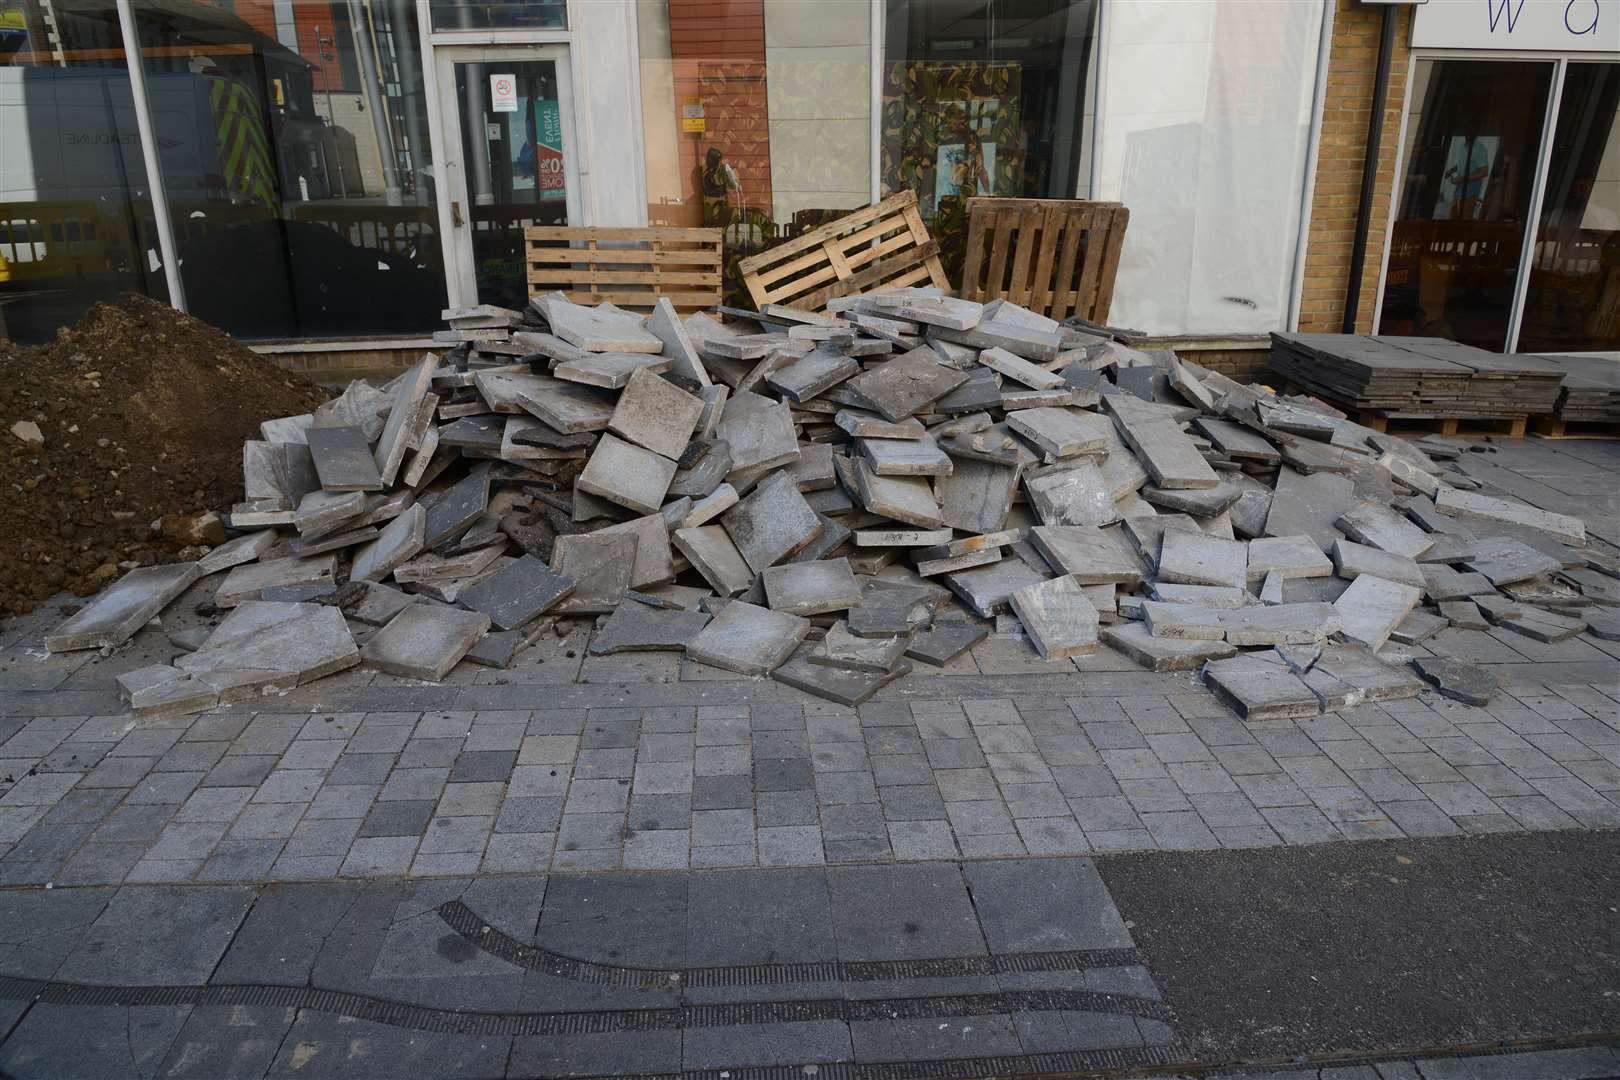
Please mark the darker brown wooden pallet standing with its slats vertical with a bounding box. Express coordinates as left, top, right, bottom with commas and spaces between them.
961, 198, 1131, 322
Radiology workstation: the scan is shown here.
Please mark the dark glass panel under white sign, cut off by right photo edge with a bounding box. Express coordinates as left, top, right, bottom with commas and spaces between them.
1518, 63, 1620, 353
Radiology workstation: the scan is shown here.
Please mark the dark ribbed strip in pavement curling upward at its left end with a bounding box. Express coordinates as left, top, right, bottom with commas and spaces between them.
439, 900, 1142, 989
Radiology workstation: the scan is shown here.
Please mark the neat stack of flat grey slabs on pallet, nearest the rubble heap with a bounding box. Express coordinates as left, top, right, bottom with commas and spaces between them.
1270, 334, 1565, 419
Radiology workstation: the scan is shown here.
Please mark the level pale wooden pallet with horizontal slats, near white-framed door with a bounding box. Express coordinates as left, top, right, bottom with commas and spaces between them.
523, 225, 726, 311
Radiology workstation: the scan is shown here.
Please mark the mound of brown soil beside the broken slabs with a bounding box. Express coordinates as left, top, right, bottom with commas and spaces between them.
0, 295, 326, 614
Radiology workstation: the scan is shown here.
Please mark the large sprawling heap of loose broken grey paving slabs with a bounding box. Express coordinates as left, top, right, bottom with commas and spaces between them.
38, 288, 1620, 719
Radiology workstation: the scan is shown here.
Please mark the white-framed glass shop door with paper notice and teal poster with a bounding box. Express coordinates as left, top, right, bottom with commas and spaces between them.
434, 45, 580, 309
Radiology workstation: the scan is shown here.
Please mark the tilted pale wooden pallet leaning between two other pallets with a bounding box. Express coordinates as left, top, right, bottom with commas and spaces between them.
737, 191, 951, 311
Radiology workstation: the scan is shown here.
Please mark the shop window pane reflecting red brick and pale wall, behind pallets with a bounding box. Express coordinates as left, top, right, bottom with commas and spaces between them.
637, 0, 872, 304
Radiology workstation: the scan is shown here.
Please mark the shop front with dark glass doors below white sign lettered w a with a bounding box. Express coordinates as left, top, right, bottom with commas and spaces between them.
1375, 0, 1620, 353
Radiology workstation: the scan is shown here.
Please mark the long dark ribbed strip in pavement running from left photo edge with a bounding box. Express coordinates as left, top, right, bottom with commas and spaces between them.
0, 976, 1171, 1036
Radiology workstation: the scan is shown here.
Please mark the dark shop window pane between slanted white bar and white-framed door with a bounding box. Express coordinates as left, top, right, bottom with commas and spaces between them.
134, 0, 446, 338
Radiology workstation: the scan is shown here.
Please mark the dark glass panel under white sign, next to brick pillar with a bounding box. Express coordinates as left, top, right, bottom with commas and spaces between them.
1379, 60, 1552, 351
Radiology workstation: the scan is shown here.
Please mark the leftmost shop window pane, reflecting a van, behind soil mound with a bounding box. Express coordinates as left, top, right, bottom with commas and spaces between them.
0, 0, 167, 342
